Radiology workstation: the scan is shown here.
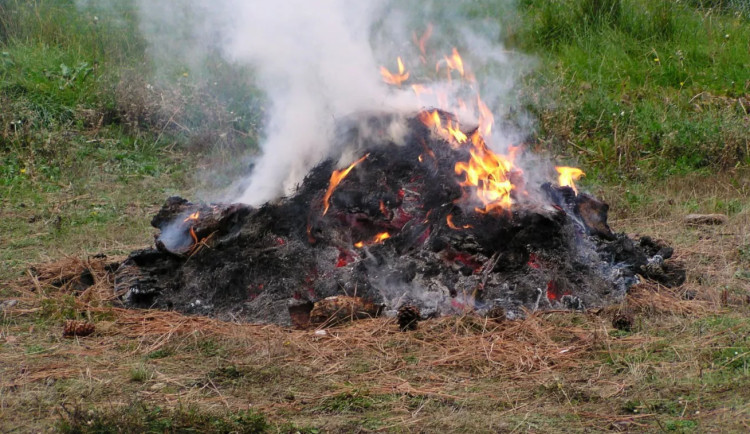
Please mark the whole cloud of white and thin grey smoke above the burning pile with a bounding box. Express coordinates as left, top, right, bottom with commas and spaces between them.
79, 0, 530, 205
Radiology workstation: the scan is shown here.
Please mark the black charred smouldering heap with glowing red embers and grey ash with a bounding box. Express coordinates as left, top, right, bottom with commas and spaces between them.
115, 112, 685, 328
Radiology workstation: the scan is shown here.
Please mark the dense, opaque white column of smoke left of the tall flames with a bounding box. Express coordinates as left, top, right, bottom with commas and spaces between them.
219, 0, 402, 205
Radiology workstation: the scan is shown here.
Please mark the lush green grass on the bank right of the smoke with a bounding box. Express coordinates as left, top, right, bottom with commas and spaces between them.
517, 0, 750, 179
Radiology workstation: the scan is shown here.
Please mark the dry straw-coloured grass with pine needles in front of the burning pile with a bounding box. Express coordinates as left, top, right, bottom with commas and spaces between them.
0, 176, 750, 432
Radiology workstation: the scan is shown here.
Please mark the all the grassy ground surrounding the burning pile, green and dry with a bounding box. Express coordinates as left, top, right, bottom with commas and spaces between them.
0, 0, 750, 432
